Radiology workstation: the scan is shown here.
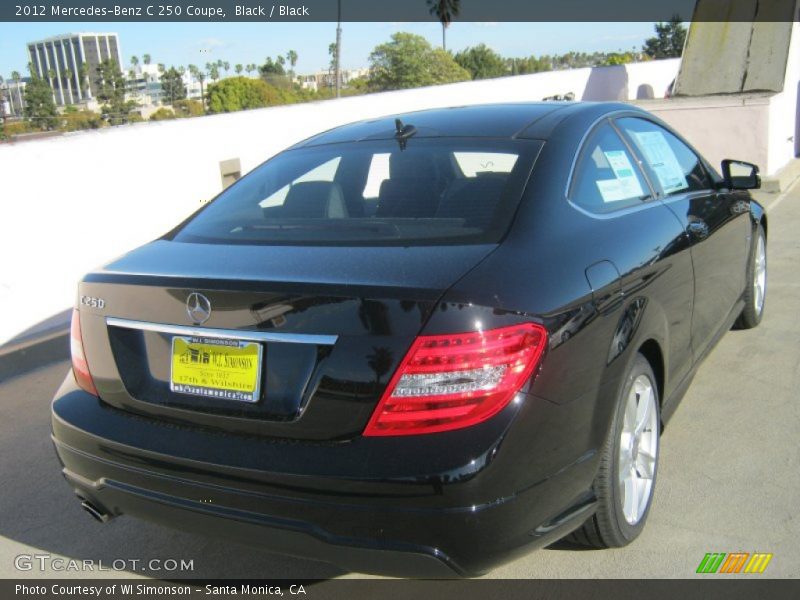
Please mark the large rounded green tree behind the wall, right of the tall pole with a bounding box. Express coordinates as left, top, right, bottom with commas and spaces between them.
369, 33, 470, 90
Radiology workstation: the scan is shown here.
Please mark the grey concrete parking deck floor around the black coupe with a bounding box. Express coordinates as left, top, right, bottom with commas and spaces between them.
0, 185, 800, 579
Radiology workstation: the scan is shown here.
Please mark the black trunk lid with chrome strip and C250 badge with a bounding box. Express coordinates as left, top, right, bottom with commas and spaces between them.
79, 240, 495, 440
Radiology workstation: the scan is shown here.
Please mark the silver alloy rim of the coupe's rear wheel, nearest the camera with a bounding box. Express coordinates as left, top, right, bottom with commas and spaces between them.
619, 375, 658, 525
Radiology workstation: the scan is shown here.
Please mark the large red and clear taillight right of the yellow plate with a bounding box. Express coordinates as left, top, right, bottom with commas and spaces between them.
364, 323, 547, 436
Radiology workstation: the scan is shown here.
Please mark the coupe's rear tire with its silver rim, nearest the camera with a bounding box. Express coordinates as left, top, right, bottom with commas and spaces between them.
568, 354, 661, 548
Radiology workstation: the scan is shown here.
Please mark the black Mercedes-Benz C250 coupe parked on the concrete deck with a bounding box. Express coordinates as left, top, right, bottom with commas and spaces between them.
52, 103, 767, 576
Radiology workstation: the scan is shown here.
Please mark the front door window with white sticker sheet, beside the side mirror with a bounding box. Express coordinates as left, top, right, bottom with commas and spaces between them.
617, 117, 712, 196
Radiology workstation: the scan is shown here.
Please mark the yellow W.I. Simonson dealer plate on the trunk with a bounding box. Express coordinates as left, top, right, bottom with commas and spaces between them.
170, 336, 261, 402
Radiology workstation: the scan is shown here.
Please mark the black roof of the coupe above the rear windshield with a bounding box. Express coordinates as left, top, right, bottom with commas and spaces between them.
293, 102, 640, 148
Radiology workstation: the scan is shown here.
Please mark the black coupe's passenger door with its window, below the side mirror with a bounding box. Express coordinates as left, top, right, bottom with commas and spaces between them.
617, 117, 751, 356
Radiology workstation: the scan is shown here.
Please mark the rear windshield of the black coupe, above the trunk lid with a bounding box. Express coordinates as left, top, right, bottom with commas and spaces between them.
172, 138, 541, 246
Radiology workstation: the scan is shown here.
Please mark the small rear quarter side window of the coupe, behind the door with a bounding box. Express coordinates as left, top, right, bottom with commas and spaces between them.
569, 123, 650, 213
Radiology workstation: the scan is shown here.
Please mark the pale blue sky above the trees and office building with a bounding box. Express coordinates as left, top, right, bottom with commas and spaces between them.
0, 21, 653, 77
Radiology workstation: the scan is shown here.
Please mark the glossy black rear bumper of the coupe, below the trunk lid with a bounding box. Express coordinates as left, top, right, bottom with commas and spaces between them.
53, 374, 596, 577
